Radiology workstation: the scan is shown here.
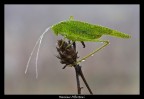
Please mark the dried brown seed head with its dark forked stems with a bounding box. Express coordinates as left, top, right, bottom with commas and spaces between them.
56, 40, 93, 94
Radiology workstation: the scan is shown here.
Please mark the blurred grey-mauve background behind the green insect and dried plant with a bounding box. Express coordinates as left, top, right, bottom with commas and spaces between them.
4, 4, 140, 94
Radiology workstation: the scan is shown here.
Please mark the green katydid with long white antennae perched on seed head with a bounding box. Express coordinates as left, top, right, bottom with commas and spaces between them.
25, 16, 131, 77
